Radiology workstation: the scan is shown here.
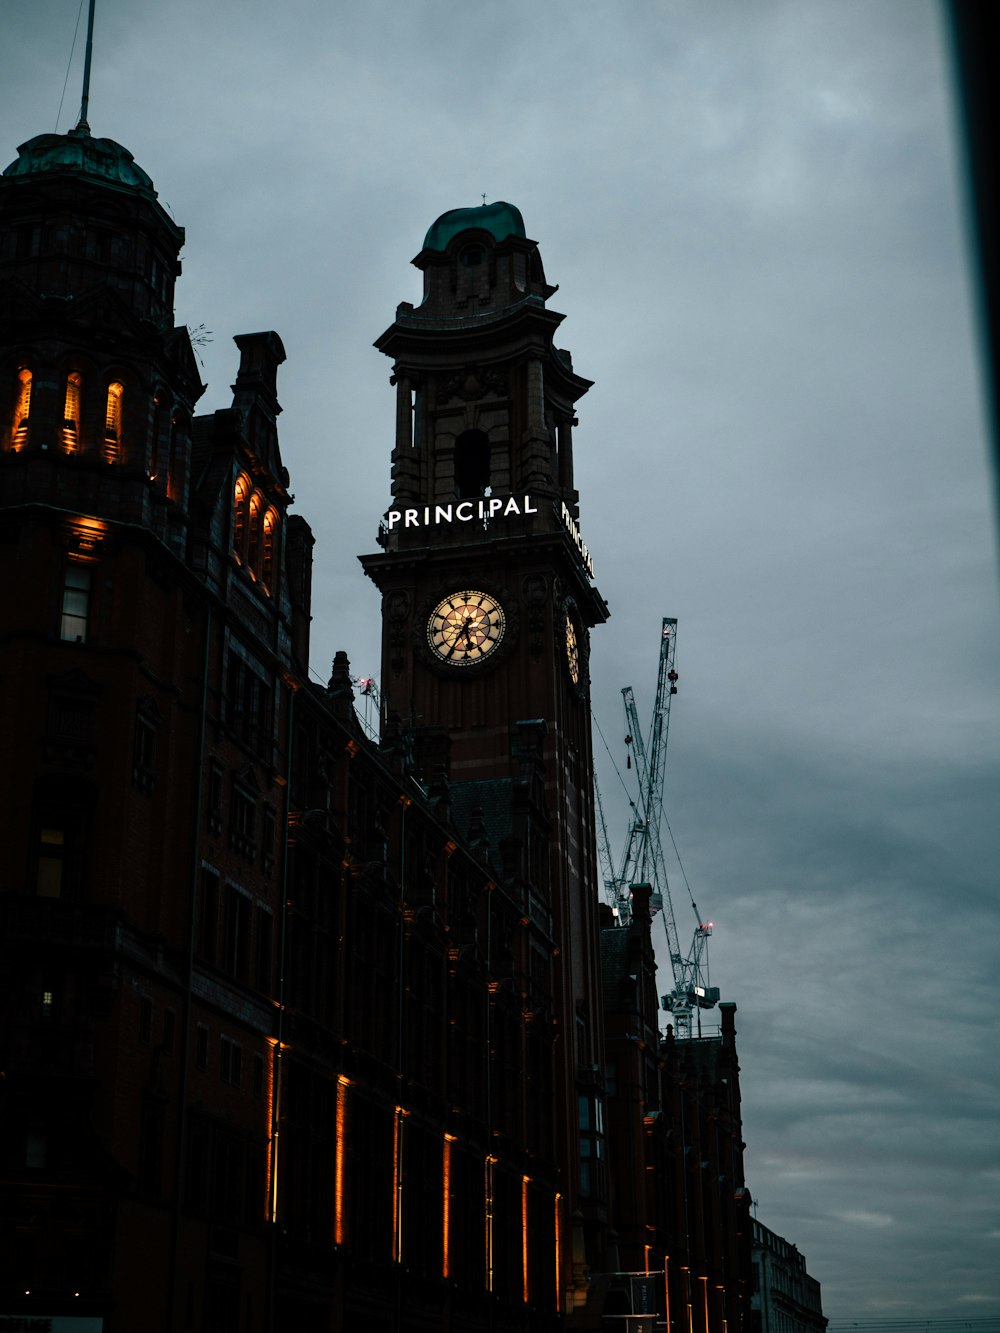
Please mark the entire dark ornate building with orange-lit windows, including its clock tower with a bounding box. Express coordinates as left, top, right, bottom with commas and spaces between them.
0, 111, 749, 1333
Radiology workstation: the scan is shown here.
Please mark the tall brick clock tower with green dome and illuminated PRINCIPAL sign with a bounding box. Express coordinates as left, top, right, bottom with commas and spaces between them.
361, 203, 611, 1314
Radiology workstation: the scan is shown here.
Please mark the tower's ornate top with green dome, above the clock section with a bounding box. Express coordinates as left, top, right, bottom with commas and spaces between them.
375, 203, 591, 549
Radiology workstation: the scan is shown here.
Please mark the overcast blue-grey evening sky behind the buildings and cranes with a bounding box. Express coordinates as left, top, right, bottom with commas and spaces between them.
0, 0, 1000, 1329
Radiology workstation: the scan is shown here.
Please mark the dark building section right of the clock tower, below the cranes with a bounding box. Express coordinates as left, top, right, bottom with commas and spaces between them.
601, 885, 751, 1333
